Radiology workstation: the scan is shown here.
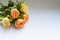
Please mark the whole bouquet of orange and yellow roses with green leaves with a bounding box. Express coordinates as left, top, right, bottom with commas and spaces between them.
0, 0, 29, 28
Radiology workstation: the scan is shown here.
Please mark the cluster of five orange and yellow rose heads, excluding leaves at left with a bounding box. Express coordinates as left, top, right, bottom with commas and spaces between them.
2, 0, 29, 28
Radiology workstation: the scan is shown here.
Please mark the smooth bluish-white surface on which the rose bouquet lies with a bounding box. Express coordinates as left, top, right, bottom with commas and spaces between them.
0, 0, 60, 40
